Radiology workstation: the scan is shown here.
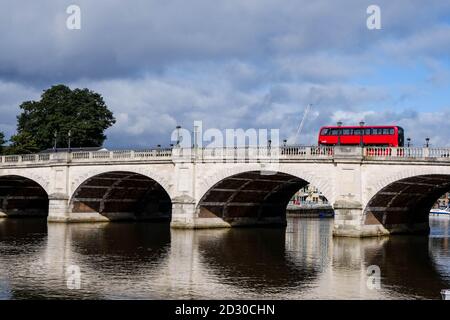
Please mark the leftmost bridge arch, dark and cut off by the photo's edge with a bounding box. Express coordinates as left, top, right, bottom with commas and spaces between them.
0, 174, 49, 217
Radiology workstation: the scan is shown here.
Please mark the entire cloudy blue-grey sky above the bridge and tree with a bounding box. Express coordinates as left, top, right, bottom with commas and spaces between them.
0, 0, 450, 148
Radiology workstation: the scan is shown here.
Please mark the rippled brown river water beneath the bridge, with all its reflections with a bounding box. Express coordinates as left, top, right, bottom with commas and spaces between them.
0, 218, 450, 299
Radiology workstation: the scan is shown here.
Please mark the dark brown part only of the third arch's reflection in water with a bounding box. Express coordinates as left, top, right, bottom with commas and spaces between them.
198, 229, 319, 294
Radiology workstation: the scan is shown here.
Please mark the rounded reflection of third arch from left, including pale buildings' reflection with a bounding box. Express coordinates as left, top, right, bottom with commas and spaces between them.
185, 219, 331, 298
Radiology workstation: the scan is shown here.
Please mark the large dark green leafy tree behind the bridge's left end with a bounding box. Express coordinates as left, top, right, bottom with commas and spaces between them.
11, 85, 116, 153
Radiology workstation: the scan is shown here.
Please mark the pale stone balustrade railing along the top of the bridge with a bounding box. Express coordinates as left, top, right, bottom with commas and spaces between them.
0, 146, 450, 166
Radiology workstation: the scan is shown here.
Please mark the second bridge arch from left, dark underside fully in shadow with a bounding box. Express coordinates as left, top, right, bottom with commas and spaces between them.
69, 170, 172, 220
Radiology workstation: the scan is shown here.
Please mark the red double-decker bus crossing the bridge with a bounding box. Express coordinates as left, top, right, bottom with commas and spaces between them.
319, 126, 404, 147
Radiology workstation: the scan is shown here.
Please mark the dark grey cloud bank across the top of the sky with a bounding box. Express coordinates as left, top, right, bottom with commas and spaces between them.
0, 0, 450, 83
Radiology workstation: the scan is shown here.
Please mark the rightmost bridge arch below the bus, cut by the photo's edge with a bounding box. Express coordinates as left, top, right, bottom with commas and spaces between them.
363, 166, 450, 234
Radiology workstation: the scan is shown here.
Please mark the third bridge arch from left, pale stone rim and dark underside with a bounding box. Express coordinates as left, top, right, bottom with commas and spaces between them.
196, 164, 332, 225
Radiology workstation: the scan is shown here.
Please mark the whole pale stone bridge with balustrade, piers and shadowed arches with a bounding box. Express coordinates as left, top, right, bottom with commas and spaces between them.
0, 146, 450, 237
